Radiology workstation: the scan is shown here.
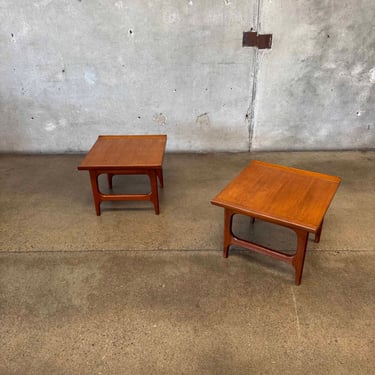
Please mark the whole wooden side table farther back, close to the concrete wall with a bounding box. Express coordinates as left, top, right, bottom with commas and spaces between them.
78, 135, 167, 216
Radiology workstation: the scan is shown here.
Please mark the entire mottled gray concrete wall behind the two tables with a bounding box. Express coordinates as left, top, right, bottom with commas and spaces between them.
0, 0, 375, 152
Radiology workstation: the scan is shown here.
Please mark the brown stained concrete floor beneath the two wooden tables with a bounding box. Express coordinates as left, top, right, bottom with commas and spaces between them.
0, 152, 375, 375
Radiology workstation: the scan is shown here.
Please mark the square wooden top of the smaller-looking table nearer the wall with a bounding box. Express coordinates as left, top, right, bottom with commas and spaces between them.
78, 134, 167, 170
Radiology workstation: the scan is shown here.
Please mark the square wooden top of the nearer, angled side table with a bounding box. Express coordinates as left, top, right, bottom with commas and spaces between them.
211, 160, 341, 233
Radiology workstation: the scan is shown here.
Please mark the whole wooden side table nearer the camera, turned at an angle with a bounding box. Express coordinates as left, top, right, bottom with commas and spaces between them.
211, 160, 341, 285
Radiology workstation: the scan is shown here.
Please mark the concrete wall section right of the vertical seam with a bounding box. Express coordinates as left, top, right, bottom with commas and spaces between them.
252, 0, 375, 150
